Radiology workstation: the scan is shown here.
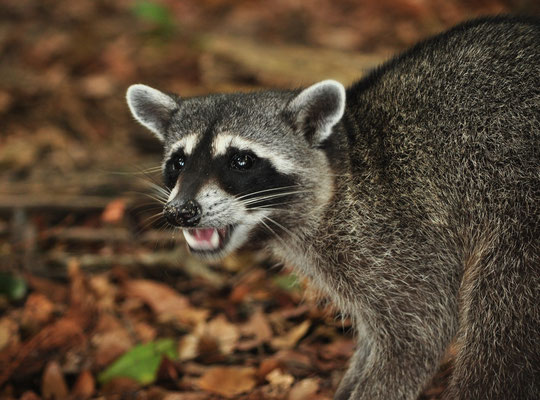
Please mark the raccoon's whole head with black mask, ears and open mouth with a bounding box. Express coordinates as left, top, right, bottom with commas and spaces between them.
127, 80, 345, 259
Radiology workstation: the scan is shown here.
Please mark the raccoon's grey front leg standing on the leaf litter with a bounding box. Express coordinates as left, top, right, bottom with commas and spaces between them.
334, 291, 457, 400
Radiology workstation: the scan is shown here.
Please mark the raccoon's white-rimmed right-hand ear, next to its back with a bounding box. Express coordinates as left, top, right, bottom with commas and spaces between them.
287, 80, 345, 146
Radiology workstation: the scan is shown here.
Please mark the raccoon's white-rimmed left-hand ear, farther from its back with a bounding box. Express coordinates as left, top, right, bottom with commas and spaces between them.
126, 84, 178, 142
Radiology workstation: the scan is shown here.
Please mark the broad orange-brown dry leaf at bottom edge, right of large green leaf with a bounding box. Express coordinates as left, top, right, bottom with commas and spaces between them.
197, 367, 256, 398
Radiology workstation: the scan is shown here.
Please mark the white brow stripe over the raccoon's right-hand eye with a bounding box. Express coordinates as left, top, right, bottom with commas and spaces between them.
212, 133, 299, 174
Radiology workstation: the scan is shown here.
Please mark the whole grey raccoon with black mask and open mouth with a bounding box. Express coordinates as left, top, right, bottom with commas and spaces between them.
127, 17, 540, 400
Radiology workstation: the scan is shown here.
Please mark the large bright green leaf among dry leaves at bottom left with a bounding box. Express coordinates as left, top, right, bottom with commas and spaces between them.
98, 339, 178, 385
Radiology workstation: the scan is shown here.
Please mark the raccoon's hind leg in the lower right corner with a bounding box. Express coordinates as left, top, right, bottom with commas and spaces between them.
445, 241, 540, 400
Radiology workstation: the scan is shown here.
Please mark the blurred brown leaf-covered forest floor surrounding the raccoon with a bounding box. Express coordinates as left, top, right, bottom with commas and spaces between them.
0, 0, 540, 400
